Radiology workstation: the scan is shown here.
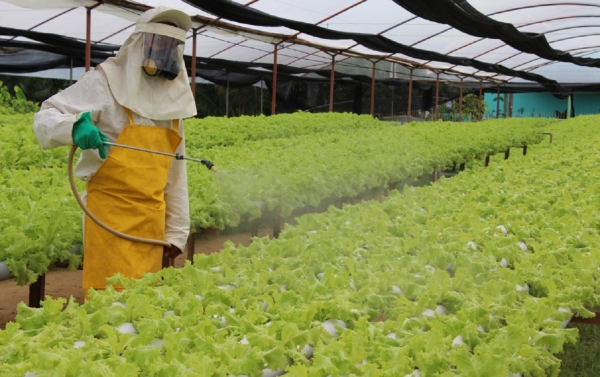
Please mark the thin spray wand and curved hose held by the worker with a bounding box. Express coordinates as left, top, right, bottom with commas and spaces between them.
67, 142, 217, 248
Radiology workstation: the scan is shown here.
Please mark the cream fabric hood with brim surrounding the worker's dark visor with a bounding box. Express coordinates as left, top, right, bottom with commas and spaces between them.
98, 6, 197, 120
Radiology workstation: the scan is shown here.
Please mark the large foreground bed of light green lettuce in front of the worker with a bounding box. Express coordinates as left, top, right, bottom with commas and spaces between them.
0, 117, 600, 377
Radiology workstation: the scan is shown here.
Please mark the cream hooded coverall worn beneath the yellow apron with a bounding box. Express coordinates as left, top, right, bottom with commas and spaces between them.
34, 7, 196, 294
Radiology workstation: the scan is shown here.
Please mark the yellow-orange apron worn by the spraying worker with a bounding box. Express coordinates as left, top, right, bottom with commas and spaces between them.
83, 108, 181, 298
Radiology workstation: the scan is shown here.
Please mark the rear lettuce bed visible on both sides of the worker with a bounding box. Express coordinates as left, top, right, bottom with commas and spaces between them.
0, 113, 553, 284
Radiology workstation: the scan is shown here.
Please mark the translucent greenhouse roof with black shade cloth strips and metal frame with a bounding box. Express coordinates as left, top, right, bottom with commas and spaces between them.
0, 0, 600, 94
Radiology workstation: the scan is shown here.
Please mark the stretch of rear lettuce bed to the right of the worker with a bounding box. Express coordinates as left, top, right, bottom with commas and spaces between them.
187, 113, 554, 229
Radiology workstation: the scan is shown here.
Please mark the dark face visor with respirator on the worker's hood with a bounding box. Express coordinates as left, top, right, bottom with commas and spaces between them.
141, 33, 183, 80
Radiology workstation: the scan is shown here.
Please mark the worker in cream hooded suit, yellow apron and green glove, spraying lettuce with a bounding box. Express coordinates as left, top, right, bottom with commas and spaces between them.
34, 7, 196, 293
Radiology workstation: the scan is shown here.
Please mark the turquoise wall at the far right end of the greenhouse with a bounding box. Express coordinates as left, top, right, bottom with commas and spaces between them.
484, 92, 600, 117
